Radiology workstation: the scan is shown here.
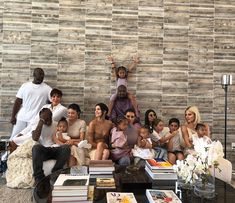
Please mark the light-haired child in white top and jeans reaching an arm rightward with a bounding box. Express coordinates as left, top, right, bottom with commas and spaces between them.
151, 119, 175, 160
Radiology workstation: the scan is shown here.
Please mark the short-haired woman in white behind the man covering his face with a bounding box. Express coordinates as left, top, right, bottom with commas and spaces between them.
9, 89, 67, 152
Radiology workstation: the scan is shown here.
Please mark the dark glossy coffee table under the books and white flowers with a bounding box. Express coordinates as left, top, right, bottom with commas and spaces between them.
33, 166, 235, 203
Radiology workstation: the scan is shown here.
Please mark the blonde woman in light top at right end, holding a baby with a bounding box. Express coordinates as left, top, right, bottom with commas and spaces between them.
180, 106, 210, 151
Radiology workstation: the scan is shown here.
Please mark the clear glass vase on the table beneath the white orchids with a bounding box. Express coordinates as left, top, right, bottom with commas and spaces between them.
194, 174, 215, 199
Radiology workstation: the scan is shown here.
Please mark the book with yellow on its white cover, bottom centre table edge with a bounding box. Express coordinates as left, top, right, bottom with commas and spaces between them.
106, 192, 137, 203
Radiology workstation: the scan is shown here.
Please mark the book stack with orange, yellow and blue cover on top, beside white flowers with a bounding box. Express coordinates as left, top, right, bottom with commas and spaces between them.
145, 159, 177, 180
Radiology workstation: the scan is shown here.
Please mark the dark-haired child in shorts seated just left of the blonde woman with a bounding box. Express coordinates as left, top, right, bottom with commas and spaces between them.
167, 118, 184, 164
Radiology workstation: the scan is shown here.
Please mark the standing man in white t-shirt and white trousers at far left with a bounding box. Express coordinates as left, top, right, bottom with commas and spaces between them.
10, 68, 51, 140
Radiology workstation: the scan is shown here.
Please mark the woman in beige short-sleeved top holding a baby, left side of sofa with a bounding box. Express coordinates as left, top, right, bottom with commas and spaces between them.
54, 104, 86, 167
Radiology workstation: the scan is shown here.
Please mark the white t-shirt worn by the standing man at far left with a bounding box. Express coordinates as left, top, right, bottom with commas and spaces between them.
16, 82, 51, 122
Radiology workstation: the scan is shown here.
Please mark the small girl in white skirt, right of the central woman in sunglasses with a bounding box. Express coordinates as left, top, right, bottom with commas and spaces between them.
132, 126, 155, 165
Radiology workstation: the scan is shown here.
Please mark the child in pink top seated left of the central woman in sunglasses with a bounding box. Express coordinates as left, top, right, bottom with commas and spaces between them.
110, 117, 131, 165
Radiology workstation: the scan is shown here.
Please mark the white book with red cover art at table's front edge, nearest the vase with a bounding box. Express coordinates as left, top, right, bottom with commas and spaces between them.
146, 189, 182, 203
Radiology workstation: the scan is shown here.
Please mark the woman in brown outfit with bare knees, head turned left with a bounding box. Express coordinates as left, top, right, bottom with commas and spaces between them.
87, 103, 113, 160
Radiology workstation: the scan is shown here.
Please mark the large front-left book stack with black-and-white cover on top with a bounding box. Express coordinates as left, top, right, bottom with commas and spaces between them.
52, 174, 94, 203
